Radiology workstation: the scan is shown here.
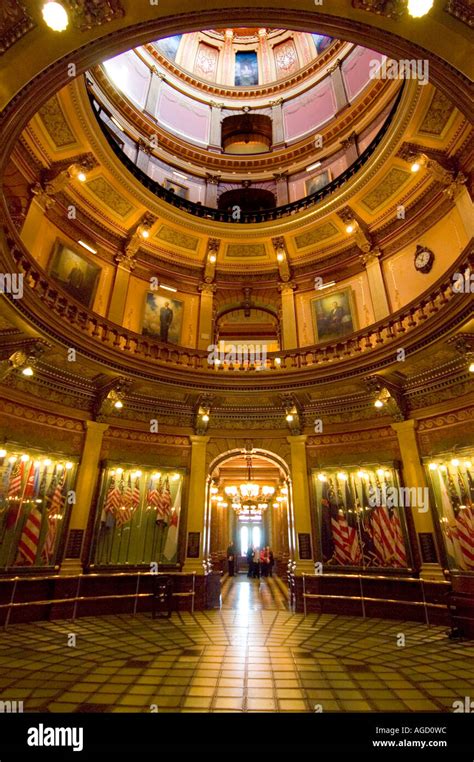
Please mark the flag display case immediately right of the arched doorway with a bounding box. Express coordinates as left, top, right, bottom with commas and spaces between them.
312, 465, 412, 569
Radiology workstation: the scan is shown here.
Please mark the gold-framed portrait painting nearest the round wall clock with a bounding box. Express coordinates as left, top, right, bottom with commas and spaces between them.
311, 288, 357, 343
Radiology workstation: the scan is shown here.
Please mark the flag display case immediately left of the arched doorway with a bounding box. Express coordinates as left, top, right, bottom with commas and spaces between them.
91, 465, 184, 567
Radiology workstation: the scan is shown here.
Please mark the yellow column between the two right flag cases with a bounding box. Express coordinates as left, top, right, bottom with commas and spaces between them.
392, 419, 442, 578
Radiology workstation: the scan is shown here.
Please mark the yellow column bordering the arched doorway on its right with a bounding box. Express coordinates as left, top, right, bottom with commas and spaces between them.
287, 434, 314, 575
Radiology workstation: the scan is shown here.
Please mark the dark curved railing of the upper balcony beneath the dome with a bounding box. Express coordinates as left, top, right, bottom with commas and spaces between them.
88, 83, 404, 224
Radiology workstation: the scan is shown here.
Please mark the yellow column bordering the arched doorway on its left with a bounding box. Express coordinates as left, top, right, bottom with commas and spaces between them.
183, 434, 210, 574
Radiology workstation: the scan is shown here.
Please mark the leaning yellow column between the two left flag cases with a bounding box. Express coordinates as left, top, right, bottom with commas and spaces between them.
60, 421, 109, 574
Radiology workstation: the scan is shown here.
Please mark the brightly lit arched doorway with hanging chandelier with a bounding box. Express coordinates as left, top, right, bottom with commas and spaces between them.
207, 448, 294, 576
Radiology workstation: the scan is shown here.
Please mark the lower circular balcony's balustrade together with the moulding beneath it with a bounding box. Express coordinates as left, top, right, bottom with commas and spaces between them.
1, 228, 474, 384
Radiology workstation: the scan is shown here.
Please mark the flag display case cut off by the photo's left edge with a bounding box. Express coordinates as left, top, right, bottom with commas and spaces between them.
0, 446, 77, 571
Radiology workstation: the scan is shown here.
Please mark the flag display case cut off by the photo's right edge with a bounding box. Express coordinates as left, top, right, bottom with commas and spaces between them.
425, 452, 474, 573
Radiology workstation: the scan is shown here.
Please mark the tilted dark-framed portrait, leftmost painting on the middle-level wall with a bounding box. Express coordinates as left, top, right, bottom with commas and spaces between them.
48, 241, 101, 307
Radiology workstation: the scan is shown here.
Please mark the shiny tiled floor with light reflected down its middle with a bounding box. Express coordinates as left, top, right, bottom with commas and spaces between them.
0, 577, 474, 712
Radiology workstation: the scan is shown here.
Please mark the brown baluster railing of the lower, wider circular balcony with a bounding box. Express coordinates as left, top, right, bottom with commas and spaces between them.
2, 229, 474, 374
